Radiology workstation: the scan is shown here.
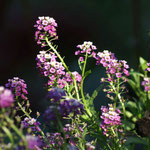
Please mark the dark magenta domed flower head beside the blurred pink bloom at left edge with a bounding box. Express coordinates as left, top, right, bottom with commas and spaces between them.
5, 77, 28, 100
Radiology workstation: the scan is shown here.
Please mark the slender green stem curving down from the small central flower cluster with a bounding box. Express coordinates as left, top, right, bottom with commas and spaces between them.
81, 52, 91, 116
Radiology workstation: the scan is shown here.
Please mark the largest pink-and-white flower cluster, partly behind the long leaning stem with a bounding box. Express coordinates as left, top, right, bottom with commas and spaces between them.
36, 51, 81, 88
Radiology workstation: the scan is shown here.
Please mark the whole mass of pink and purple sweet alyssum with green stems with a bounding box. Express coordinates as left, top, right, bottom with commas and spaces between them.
0, 16, 150, 150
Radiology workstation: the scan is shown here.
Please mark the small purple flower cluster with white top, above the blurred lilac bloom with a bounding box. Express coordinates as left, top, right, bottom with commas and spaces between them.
21, 117, 41, 132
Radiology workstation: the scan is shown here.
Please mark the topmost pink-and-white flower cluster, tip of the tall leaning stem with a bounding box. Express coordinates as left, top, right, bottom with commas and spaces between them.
34, 16, 58, 47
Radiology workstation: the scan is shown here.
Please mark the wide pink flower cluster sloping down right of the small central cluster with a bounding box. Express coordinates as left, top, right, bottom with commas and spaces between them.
96, 50, 129, 81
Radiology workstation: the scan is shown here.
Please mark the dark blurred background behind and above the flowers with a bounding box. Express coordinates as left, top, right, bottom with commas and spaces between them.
0, 0, 150, 112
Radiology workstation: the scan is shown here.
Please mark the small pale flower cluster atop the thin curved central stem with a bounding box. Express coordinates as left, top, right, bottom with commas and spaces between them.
75, 41, 97, 62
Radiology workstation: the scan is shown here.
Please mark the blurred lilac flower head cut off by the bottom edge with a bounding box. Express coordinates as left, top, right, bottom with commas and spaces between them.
25, 135, 42, 150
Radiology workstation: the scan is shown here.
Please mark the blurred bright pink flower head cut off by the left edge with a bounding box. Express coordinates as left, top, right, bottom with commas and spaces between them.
0, 86, 14, 108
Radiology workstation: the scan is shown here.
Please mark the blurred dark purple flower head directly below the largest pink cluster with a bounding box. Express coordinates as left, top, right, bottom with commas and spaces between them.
47, 87, 66, 103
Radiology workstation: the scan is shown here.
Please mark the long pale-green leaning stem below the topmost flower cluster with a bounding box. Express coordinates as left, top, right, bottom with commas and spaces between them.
45, 37, 80, 100
